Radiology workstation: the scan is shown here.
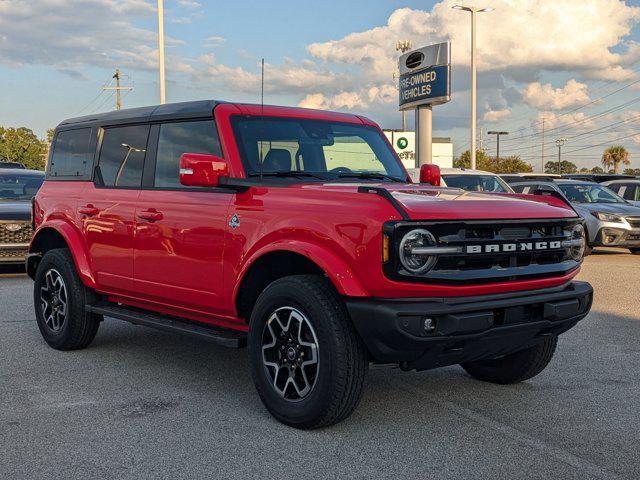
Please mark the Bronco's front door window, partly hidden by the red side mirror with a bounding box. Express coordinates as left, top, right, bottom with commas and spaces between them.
155, 120, 222, 188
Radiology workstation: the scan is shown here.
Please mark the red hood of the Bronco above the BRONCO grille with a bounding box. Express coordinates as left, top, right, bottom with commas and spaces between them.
309, 183, 578, 220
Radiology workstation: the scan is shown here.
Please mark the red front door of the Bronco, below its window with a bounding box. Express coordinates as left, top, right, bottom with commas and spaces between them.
134, 190, 233, 314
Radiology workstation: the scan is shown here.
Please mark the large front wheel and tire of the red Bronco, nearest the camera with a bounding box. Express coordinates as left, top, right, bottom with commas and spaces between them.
248, 275, 368, 429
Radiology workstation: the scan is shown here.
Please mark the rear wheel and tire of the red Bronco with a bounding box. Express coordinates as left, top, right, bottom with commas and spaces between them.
33, 248, 102, 350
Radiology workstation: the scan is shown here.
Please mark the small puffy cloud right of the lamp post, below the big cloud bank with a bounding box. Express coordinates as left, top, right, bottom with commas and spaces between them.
522, 79, 591, 110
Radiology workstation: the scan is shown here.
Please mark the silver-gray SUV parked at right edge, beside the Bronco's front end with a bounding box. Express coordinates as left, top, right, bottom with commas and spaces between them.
510, 179, 640, 255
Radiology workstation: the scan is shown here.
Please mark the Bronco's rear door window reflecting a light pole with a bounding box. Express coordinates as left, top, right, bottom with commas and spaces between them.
95, 125, 149, 187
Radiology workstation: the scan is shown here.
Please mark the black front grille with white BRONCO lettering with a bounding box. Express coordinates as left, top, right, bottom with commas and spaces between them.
384, 219, 579, 284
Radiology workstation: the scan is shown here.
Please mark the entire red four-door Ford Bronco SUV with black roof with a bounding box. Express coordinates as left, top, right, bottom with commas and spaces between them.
27, 101, 592, 428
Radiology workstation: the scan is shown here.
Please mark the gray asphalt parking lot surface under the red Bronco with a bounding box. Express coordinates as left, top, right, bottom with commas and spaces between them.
0, 250, 640, 479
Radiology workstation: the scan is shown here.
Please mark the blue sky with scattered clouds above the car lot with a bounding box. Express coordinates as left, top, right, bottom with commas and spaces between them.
0, 0, 640, 167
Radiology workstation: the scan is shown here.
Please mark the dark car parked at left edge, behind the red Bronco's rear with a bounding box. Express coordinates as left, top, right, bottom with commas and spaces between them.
0, 168, 44, 265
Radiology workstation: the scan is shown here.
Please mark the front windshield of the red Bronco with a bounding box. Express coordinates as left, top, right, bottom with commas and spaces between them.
232, 116, 406, 181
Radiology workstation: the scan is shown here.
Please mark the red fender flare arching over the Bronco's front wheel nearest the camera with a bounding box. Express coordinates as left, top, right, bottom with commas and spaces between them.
233, 240, 369, 298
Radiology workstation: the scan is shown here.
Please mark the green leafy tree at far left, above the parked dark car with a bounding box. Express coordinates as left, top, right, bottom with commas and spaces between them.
0, 127, 47, 170
